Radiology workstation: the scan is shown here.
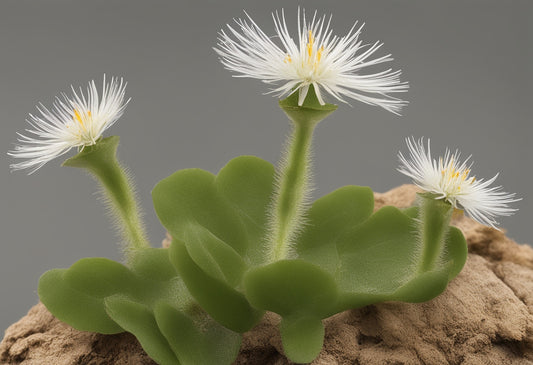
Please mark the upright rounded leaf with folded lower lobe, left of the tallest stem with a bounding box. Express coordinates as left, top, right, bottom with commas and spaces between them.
152, 169, 248, 295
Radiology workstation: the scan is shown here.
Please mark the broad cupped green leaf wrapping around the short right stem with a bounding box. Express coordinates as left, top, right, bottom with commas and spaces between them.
336, 207, 466, 309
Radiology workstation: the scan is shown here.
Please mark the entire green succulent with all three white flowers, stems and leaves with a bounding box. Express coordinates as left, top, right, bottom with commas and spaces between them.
11, 8, 517, 364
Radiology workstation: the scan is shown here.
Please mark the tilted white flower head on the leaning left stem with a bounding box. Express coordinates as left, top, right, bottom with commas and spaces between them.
8, 76, 129, 174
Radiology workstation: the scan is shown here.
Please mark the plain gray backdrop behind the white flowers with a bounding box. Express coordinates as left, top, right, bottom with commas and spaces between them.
0, 0, 533, 331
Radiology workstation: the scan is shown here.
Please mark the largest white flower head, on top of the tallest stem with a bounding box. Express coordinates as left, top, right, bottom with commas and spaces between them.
215, 10, 409, 114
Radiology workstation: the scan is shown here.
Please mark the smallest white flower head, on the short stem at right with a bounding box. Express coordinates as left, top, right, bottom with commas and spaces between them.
398, 139, 521, 228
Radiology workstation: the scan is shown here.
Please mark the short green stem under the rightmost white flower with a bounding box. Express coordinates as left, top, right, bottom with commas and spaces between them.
418, 194, 453, 273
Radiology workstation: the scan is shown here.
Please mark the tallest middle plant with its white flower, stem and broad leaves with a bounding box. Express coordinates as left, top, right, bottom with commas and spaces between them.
153, 8, 466, 362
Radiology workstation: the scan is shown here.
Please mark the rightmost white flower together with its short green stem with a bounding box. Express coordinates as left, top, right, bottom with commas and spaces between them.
398, 139, 520, 271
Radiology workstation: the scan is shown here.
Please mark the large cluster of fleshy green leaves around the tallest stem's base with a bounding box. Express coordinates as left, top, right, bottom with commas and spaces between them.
148, 154, 466, 362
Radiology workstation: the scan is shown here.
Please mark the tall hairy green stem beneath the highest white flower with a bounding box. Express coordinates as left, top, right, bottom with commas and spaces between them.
269, 123, 316, 261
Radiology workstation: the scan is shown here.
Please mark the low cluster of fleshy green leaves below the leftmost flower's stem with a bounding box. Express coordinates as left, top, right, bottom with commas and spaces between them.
39, 248, 240, 365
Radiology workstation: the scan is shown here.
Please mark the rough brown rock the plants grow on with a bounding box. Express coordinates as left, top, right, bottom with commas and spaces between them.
0, 185, 533, 365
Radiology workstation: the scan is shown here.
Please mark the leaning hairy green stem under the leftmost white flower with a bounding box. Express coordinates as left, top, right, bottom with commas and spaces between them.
63, 136, 150, 251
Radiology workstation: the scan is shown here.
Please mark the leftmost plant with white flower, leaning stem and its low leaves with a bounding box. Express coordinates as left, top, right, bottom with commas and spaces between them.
10, 78, 241, 365
